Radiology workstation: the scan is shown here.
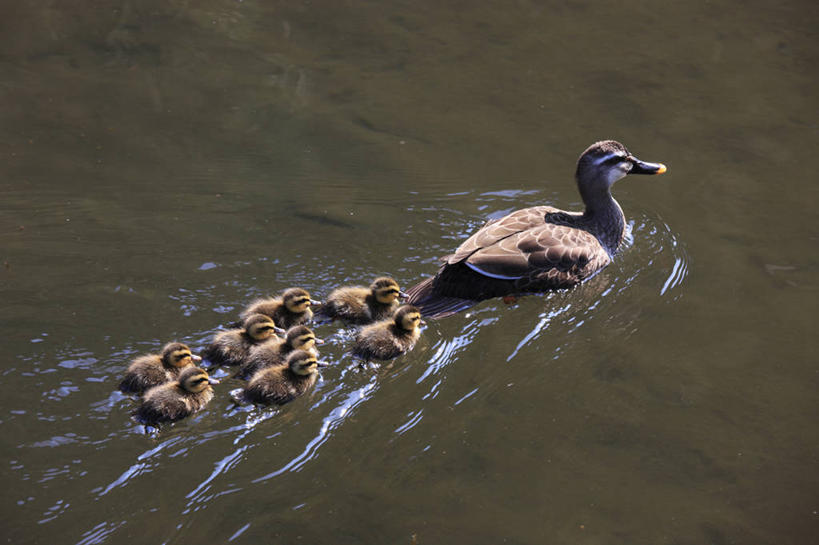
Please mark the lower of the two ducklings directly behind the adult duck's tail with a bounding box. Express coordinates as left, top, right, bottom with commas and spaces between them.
352, 305, 424, 361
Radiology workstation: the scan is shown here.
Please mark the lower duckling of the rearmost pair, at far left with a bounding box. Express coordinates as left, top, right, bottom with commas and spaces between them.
134, 367, 219, 426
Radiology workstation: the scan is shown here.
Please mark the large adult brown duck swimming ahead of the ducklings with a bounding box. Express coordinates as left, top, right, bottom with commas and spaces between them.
408, 140, 666, 318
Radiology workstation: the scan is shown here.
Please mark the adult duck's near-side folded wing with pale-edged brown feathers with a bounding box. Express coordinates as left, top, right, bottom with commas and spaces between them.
464, 223, 607, 287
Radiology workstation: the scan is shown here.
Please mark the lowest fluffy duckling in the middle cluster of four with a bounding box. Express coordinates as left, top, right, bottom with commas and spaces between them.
241, 349, 328, 405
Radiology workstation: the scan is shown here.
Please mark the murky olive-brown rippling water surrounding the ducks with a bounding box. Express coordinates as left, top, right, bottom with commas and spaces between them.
0, 0, 819, 545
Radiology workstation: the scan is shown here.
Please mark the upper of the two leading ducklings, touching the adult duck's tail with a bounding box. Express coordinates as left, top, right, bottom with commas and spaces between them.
316, 276, 408, 325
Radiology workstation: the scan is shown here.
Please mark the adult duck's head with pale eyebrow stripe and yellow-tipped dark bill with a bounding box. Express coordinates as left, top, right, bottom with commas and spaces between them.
575, 140, 666, 196
